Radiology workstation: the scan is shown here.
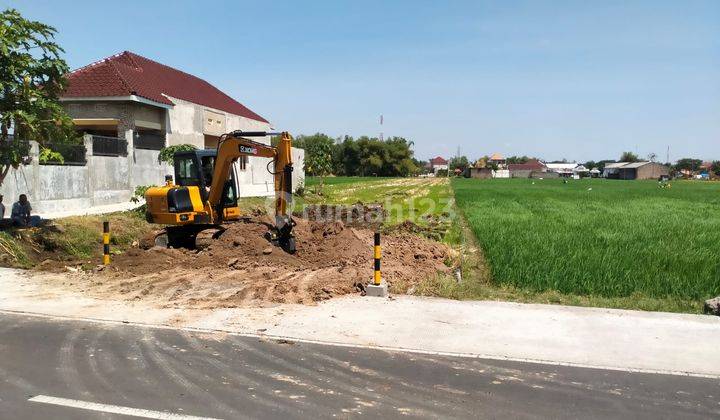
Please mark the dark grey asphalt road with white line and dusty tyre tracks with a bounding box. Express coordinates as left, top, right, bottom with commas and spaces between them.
0, 314, 720, 419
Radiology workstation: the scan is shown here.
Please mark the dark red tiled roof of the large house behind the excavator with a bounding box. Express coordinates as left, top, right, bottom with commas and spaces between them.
63, 51, 268, 122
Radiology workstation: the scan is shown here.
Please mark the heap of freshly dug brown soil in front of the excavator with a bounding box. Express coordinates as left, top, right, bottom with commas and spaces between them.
83, 217, 451, 308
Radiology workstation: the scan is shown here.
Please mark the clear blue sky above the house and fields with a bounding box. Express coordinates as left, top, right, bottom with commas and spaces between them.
7, 0, 720, 161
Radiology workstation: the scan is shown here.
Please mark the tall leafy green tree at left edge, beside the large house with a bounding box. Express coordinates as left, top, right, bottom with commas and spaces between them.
0, 9, 79, 184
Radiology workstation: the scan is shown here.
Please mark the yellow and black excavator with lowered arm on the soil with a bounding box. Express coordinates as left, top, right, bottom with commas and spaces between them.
145, 130, 295, 254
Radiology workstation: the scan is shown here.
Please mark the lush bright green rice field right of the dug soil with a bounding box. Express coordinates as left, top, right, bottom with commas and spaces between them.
452, 179, 720, 300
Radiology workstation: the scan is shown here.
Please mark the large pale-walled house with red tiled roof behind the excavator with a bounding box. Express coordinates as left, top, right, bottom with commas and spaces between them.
60, 51, 304, 196
